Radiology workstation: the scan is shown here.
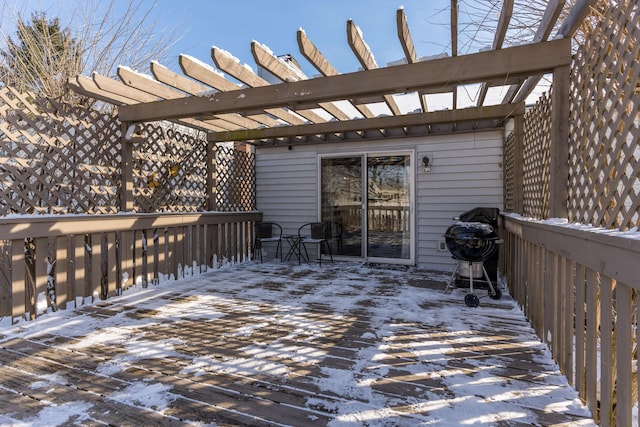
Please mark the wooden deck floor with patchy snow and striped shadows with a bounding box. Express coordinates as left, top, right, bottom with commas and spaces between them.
0, 263, 594, 426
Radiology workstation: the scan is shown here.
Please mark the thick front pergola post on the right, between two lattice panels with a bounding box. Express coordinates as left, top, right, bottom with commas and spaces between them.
549, 65, 571, 218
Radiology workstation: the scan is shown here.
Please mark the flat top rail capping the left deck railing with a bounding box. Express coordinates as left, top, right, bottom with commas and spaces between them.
0, 211, 262, 240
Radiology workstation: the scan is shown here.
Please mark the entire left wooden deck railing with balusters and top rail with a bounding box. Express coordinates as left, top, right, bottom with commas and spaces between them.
0, 212, 262, 323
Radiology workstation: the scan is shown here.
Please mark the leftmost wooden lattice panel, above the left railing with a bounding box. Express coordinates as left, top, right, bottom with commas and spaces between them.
0, 87, 121, 215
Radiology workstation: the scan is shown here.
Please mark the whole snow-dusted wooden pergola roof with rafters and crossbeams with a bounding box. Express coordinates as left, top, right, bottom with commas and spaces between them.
70, 0, 594, 146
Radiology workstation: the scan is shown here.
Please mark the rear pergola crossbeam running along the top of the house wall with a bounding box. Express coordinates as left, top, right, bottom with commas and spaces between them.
208, 103, 525, 142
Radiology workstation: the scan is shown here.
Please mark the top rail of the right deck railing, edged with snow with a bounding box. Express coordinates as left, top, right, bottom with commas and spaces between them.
502, 215, 640, 290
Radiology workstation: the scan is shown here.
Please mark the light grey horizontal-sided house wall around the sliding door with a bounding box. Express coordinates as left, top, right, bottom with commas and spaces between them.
256, 129, 504, 271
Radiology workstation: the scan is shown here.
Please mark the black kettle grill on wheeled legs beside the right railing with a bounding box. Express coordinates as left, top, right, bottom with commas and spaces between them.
444, 208, 502, 307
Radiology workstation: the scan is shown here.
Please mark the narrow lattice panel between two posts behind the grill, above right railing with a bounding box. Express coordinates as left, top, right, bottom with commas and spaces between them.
522, 89, 551, 219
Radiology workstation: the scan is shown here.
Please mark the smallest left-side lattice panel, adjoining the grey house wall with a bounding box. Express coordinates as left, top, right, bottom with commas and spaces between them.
216, 146, 256, 212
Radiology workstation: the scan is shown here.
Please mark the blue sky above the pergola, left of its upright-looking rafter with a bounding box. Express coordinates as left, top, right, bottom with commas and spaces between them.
2, 0, 450, 76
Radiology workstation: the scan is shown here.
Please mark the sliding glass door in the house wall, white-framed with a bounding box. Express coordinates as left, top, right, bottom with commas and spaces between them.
320, 153, 413, 263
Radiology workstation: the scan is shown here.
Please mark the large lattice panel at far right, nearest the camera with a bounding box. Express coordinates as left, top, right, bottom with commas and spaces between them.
569, 2, 640, 230
